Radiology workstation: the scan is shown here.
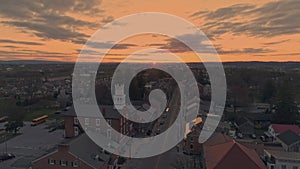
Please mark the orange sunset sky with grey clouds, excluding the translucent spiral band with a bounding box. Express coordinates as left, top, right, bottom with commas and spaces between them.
0, 0, 300, 62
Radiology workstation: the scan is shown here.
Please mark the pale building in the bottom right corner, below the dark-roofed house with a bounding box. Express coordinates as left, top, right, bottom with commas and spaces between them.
265, 149, 300, 169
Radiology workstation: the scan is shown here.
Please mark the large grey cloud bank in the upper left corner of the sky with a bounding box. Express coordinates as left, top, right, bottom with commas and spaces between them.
0, 0, 102, 43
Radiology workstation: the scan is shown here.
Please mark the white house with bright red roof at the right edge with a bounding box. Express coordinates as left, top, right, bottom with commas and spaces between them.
268, 124, 300, 140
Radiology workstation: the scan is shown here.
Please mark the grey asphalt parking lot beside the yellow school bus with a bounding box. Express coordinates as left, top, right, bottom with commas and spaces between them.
0, 122, 63, 169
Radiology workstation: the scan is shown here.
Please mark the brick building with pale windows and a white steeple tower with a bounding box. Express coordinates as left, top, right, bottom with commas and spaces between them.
64, 84, 133, 140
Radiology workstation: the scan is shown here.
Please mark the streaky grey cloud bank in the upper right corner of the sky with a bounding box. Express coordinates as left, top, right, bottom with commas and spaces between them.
192, 0, 300, 37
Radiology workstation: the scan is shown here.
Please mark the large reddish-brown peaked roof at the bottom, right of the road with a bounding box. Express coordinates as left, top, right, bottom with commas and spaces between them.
204, 140, 266, 169
